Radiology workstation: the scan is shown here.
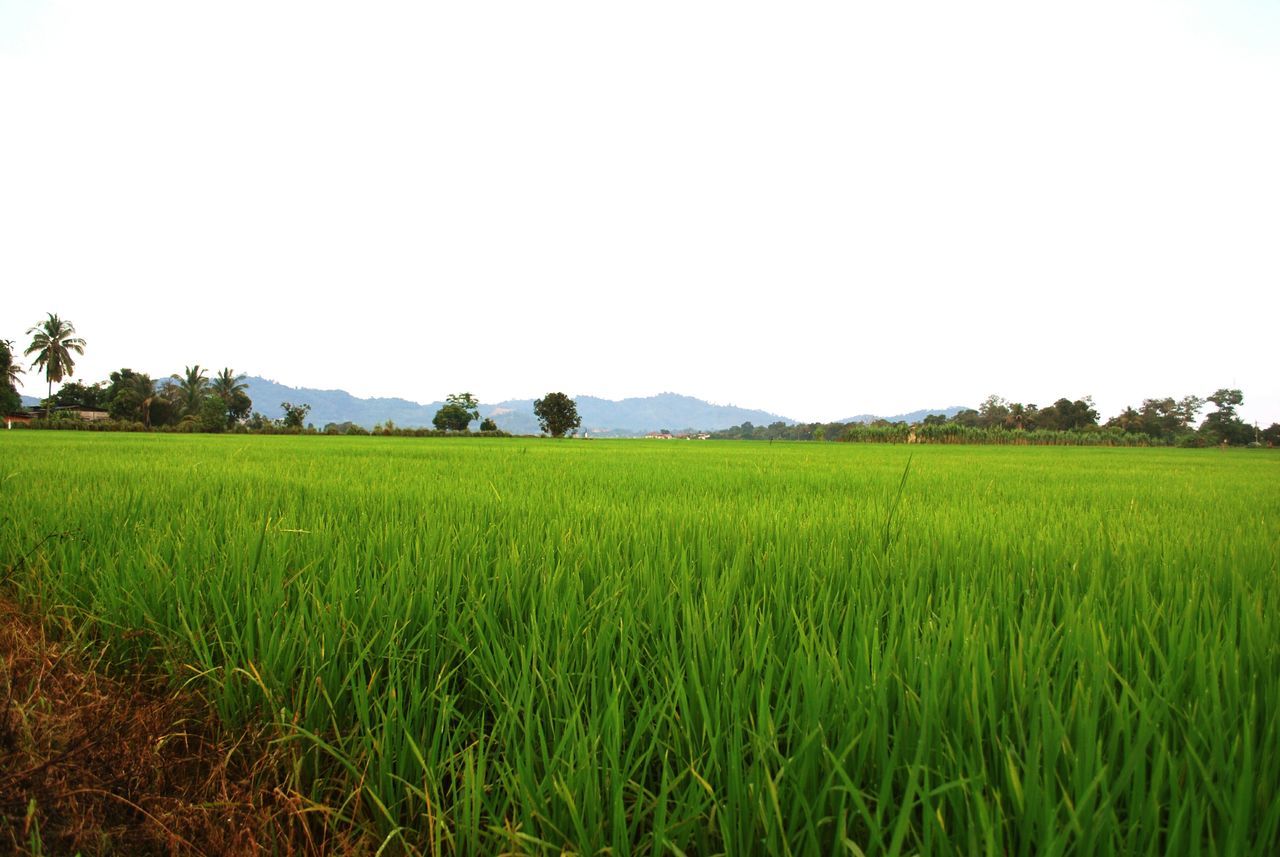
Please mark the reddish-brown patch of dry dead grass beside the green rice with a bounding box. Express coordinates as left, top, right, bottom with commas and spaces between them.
0, 596, 360, 856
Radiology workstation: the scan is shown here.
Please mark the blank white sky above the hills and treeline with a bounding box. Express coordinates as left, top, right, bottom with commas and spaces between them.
0, 0, 1280, 426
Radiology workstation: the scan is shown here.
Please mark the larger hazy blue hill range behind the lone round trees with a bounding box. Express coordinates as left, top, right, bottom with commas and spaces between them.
235, 376, 794, 437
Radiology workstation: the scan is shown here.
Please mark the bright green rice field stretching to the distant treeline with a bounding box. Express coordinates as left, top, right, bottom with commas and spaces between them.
0, 440, 1280, 854
